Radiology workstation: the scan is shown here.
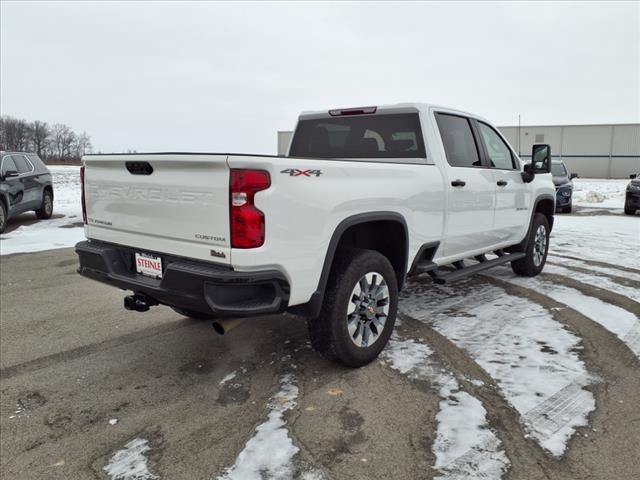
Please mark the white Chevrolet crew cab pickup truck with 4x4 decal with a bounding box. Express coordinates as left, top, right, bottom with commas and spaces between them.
76, 103, 555, 367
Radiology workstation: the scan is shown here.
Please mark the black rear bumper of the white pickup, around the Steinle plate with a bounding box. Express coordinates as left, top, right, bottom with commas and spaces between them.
76, 241, 289, 316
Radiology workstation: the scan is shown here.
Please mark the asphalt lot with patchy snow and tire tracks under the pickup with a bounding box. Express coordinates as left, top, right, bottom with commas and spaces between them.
0, 170, 640, 480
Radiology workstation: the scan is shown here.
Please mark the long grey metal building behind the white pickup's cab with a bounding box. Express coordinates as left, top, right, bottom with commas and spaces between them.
278, 123, 640, 178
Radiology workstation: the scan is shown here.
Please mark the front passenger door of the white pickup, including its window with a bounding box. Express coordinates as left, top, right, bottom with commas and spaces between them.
472, 120, 531, 243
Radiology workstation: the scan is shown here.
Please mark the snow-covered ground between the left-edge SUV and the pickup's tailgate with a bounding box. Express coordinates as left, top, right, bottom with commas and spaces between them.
0, 165, 84, 255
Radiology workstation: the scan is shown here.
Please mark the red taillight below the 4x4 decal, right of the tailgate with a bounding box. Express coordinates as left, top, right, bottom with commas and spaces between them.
229, 168, 271, 248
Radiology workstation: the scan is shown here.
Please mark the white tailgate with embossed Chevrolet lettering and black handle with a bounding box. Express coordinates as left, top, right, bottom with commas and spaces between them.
83, 154, 231, 264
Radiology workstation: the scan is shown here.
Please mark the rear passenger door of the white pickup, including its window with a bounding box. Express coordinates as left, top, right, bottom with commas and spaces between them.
435, 112, 497, 257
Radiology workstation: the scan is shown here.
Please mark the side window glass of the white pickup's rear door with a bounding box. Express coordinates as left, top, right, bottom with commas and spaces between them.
436, 113, 482, 167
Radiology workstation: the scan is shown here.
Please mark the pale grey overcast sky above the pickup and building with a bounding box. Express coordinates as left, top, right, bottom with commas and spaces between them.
1, 0, 640, 153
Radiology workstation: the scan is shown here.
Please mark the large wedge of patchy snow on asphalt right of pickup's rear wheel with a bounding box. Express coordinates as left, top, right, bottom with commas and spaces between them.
400, 281, 595, 456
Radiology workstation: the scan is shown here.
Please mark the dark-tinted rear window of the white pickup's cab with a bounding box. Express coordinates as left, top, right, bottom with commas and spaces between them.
289, 113, 426, 158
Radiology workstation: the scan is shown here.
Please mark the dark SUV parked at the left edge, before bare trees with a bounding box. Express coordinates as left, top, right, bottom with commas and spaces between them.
0, 152, 53, 233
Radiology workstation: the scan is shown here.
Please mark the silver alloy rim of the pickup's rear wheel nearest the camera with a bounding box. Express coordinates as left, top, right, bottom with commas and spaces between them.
347, 272, 389, 348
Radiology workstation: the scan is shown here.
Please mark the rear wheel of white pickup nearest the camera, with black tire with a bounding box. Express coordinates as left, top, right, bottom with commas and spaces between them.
308, 249, 398, 368
